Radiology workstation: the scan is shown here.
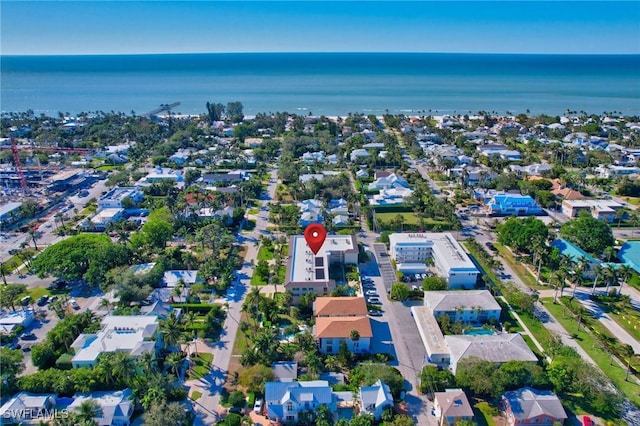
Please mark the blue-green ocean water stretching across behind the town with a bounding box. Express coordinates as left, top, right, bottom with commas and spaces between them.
0, 53, 640, 115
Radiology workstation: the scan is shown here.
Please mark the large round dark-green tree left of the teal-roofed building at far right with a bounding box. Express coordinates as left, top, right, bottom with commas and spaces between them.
560, 213, 615, 256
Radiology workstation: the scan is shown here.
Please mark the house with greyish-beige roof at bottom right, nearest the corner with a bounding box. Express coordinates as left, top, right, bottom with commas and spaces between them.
502, 387, 567, 426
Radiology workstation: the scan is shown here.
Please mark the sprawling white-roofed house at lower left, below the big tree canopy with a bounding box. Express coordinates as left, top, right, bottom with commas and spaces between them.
71, 315, 162, 368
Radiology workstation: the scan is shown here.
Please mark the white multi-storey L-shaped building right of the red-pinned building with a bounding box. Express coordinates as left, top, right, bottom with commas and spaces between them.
389, 232, 480, 288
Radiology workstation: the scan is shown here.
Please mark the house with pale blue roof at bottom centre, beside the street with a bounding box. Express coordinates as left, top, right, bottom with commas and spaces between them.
264, 380, 338, 424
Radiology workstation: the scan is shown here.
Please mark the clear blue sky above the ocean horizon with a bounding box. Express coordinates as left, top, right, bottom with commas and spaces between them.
0, 0, 640, 55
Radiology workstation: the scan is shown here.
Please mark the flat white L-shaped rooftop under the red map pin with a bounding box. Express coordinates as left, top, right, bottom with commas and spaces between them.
288, 235, 358, 282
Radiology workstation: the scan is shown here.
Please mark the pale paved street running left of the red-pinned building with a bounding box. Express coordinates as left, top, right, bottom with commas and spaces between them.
194, 170, 277, 426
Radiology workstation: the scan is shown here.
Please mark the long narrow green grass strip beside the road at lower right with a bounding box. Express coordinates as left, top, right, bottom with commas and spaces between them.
541, 298, 640, 406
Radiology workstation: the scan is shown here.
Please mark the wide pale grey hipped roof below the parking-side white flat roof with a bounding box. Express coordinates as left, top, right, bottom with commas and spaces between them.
444, 333, 538, 374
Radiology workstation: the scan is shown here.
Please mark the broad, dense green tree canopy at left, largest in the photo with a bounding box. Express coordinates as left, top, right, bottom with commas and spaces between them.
33, 233, 131, 285
